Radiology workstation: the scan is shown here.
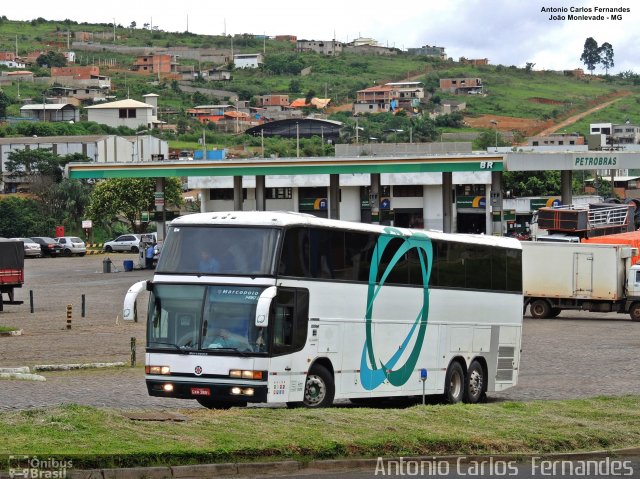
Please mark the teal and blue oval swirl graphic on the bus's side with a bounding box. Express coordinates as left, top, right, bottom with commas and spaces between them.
360, 227, 433, 391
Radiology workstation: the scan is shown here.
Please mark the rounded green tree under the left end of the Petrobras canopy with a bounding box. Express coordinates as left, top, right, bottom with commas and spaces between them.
86, 178, 182, 233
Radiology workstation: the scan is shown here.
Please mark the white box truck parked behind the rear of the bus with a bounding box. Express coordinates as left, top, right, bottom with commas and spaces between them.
522, 241, 640, 321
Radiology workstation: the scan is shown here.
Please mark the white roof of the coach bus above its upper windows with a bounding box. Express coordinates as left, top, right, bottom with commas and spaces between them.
171, 211, 522, 249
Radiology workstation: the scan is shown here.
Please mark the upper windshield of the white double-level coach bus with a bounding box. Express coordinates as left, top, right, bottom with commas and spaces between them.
156, 225, 279, 275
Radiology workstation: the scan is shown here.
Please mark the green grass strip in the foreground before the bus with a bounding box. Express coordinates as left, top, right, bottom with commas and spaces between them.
0, 396, 640, 467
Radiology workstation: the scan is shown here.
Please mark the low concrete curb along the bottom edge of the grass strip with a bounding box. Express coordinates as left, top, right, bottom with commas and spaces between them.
15, 447, 640, 479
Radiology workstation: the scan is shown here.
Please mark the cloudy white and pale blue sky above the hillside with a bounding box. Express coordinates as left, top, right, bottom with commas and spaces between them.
0, 0, 640, 73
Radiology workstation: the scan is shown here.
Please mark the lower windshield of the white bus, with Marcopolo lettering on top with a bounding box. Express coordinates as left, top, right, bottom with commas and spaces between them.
147, 284, 267, 353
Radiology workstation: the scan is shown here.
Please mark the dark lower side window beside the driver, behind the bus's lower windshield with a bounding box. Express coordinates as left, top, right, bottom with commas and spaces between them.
273, 288, 309, 354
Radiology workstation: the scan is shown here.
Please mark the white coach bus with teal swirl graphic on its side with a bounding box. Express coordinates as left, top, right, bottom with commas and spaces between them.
123, 212, 523, 408
